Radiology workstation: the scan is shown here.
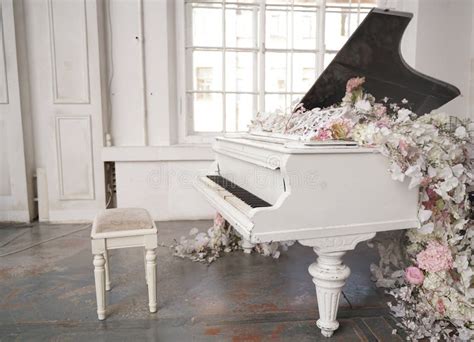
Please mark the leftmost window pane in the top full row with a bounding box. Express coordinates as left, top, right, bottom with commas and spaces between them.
188, 7, 222, 47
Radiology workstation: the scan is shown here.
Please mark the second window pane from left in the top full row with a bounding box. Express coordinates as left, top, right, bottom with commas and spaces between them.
225, 7, 258, 48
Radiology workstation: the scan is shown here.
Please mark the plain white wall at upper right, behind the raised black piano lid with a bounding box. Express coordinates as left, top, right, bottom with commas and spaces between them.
379, 0, 474, 118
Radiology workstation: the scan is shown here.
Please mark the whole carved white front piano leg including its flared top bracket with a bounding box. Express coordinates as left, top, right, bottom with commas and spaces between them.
299, 233, 375, 337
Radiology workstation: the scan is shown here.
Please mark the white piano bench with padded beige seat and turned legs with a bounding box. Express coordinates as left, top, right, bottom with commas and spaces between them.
91, 208, 158, 320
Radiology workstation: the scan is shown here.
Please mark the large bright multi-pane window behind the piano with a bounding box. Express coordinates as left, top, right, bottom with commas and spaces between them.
183, 0, 376, 135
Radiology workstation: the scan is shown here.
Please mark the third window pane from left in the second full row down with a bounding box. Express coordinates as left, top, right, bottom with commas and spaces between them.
265, 52, 291, 92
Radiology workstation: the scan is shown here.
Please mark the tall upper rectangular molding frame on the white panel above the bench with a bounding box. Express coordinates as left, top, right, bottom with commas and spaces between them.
48, 0, 90, 104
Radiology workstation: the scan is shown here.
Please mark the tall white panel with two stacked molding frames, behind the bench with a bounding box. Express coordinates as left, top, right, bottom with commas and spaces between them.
19, 0, 105, 221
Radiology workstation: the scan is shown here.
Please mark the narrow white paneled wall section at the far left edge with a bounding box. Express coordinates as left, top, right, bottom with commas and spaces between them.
0, 0, 35, 221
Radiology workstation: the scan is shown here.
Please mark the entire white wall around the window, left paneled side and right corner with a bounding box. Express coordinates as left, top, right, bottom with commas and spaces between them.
0, 0, 474, 221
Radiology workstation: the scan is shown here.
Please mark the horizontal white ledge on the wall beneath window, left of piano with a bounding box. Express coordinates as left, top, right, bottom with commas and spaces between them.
102, 144, 214, 162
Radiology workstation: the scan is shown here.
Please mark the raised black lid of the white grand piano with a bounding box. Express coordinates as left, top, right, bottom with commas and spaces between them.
301, 8, 460, 115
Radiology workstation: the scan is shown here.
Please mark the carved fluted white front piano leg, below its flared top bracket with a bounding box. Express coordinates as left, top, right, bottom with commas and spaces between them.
308, 250, 351, 337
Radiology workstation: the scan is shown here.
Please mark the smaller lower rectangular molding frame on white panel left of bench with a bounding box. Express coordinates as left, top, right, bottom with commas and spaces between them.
56, 115, 95, 200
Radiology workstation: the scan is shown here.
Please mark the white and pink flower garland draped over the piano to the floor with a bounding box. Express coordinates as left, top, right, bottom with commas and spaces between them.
250, 77, 474, 340
